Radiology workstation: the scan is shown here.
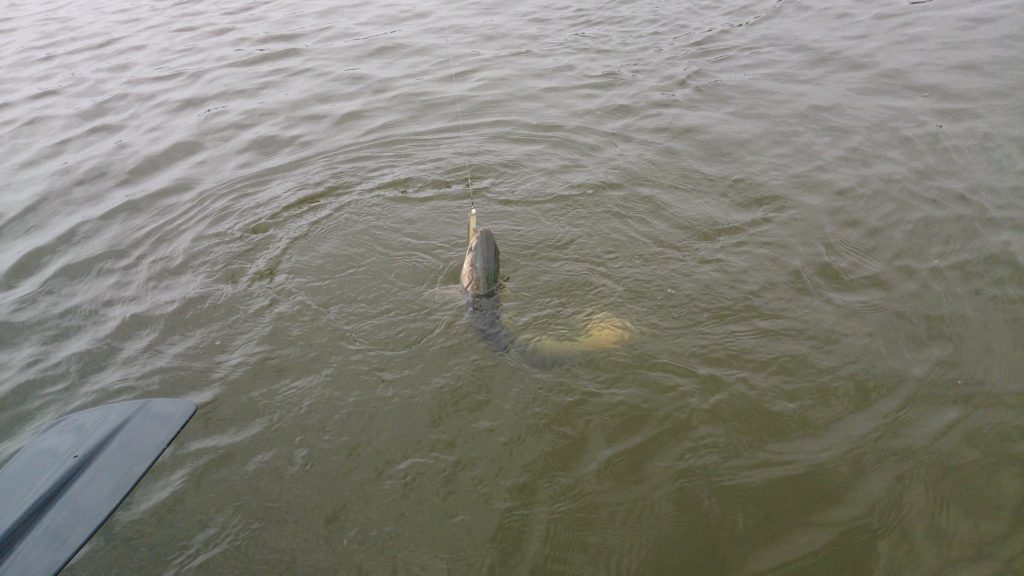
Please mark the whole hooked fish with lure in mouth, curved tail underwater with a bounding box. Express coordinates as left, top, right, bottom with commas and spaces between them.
460, 209, 634, 368
